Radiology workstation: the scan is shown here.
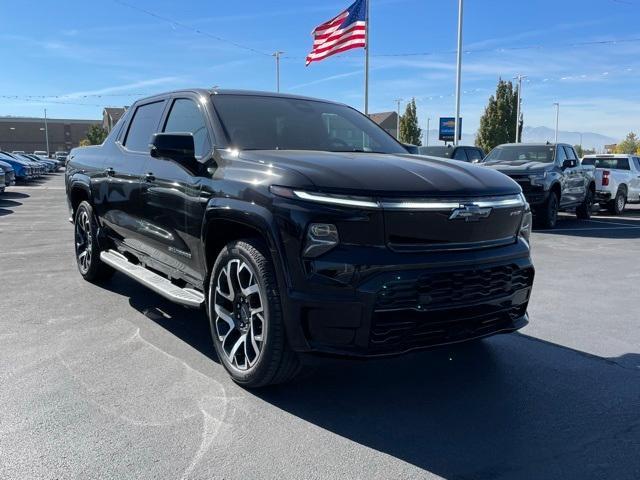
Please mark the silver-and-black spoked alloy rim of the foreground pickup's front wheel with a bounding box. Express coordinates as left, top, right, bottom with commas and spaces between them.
213, 258, 267, 371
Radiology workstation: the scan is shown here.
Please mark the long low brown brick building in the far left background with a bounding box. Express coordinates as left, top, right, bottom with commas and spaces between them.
0, 117, 102, 152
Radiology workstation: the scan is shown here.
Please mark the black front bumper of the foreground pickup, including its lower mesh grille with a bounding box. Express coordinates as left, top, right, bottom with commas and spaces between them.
283, 242, 534, 357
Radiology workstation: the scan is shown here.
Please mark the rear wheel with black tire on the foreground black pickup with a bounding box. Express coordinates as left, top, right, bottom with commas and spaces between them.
73, 201, 114, 282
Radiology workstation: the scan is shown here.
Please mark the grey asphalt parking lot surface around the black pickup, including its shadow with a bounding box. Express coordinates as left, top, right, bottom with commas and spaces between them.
0, 173, 640, 479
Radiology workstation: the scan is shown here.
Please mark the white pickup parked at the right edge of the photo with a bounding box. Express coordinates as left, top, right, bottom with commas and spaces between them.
582, 154, 640, 215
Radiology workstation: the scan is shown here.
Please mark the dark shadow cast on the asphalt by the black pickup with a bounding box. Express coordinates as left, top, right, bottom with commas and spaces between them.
100, 274, 640, 479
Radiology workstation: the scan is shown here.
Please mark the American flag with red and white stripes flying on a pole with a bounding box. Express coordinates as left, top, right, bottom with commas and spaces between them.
306, 0, 369, 66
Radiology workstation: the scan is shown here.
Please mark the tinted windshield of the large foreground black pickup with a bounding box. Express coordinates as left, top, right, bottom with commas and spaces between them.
213, 95, 407, 153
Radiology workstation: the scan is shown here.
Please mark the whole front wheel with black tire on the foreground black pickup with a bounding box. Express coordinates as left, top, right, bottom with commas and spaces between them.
207, 239, 301, 388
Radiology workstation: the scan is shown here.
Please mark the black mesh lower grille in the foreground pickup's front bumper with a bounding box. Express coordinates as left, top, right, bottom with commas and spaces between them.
375, 265, 533, 310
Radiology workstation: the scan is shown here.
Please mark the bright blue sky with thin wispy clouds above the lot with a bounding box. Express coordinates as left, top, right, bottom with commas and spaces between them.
0, 0, 640, 137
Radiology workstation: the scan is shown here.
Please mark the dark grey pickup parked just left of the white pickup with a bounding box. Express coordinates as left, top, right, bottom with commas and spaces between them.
483, 143, 596, 228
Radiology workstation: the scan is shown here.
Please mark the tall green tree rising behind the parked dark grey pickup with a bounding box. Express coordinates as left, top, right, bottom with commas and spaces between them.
476, 79, 523, 152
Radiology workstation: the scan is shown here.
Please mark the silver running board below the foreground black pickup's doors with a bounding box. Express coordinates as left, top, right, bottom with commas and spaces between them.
100, 250, 204, 308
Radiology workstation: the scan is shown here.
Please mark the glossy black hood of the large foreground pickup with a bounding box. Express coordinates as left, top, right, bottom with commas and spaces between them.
241, 150, 520, 197
